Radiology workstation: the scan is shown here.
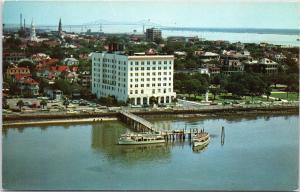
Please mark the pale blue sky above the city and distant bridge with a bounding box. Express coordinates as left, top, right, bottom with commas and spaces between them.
2, 0, 300, 29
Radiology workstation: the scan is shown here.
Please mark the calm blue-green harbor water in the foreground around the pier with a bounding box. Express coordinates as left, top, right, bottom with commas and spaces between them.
2, 115, 299, 191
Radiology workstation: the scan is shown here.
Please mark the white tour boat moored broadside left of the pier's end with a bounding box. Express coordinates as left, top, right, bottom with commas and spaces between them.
118, 133, 165, 145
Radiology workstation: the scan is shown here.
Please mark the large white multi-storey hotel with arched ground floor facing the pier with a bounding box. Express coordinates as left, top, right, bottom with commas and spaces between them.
92, 52, 176, 105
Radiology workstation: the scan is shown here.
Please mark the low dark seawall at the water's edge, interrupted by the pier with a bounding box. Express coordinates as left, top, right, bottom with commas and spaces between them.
2, 106, 299, 128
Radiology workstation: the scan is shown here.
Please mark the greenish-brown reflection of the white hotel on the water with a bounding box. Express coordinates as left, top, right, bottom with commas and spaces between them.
92, 122, 171, 164
